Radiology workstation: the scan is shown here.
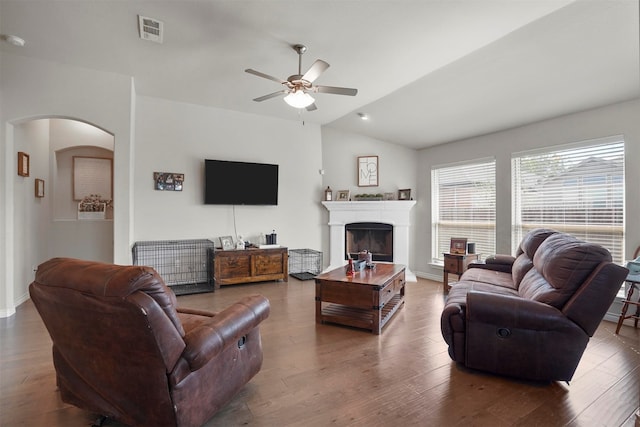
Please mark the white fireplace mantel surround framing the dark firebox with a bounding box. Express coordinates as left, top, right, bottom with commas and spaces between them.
322, 200, 417, 282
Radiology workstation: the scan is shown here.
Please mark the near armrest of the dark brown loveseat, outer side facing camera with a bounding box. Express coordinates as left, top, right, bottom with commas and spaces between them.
465, 291, 589, 381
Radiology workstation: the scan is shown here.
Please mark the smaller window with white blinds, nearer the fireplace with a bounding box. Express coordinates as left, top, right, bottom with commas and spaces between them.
431, 159, 496, 261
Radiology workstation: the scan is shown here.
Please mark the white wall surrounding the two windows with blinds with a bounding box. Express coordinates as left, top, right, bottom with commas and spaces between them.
414, 100, 640, 280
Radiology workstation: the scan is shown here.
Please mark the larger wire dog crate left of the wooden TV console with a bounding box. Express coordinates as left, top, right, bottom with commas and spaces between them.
132, 239, 215, 295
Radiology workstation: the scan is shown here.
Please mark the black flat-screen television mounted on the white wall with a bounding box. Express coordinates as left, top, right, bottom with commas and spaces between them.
204, 159, 278, 205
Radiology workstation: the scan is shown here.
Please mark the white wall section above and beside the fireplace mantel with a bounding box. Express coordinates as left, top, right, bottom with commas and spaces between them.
317, 126, 426, 269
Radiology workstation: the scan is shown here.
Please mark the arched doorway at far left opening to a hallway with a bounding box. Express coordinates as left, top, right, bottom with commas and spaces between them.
9, 118, 115, 316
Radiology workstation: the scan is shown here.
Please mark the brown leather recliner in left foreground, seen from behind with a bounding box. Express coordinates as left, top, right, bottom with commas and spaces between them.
29, 258, 269, 426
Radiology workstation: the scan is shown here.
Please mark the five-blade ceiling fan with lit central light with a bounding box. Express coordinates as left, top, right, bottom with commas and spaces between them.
244, 44, 358, 111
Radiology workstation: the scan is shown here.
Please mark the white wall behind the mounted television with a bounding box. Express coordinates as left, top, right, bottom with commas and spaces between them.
134, 96, 322, 256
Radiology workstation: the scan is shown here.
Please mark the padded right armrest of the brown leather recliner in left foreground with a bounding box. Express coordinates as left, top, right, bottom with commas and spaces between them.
182, 295, 270, 371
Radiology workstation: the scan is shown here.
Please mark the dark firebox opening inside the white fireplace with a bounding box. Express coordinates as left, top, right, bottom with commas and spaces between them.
344, 222, 393, 262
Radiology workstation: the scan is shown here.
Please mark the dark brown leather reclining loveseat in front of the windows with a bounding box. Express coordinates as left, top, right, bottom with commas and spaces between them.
441, 229, 627, 381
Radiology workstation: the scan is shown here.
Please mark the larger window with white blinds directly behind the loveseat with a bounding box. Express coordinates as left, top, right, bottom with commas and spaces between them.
511, 136, 624, 263
